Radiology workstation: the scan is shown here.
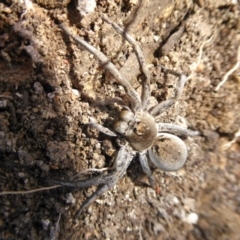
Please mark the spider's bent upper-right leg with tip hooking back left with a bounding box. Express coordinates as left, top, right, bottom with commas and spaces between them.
149, 69, 188, 117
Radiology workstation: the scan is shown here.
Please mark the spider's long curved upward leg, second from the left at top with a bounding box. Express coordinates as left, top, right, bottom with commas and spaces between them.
101, 14, 150, 110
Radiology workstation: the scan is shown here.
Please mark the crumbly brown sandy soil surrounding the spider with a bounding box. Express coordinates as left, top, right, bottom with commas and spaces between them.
0, 0, 240, 240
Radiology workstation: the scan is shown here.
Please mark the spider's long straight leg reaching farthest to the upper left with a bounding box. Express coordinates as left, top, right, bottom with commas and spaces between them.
59, 24, 141, 111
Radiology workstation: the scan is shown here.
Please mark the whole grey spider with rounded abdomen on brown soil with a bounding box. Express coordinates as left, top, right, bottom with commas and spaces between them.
47, 15, 198, 218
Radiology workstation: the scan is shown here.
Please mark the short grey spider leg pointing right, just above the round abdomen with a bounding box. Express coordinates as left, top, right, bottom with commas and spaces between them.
157, 123, 199, 137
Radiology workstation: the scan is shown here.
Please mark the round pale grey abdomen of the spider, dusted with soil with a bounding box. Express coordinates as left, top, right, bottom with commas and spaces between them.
148, 133, 188, 171
